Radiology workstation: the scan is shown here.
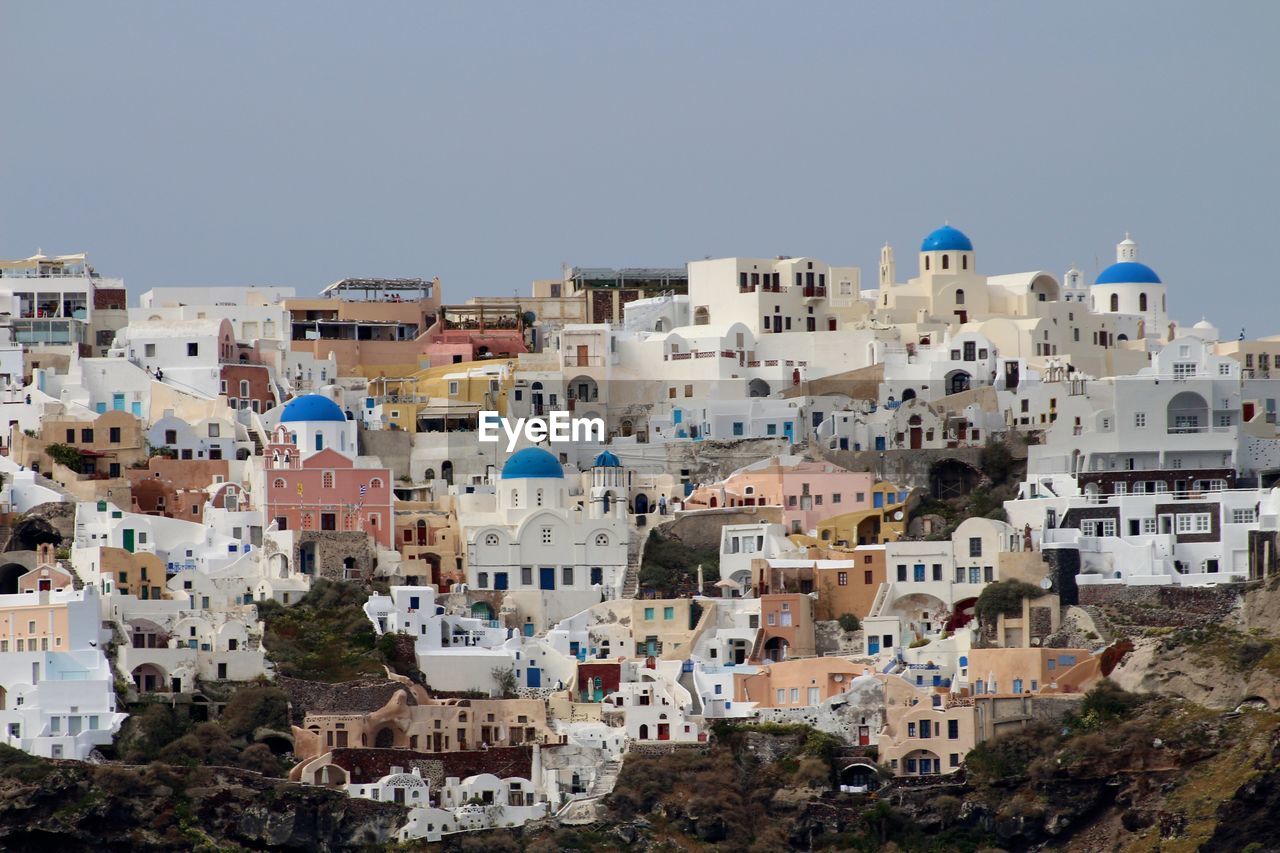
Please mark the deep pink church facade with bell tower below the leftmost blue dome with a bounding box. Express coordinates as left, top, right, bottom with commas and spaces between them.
262, 430, 396, 548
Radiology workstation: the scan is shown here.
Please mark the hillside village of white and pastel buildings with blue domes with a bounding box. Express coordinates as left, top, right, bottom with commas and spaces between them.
0, 224, 1280, 849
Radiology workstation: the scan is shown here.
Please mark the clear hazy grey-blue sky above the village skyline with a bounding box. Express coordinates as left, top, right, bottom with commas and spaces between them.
0, 0, 1280, 337
